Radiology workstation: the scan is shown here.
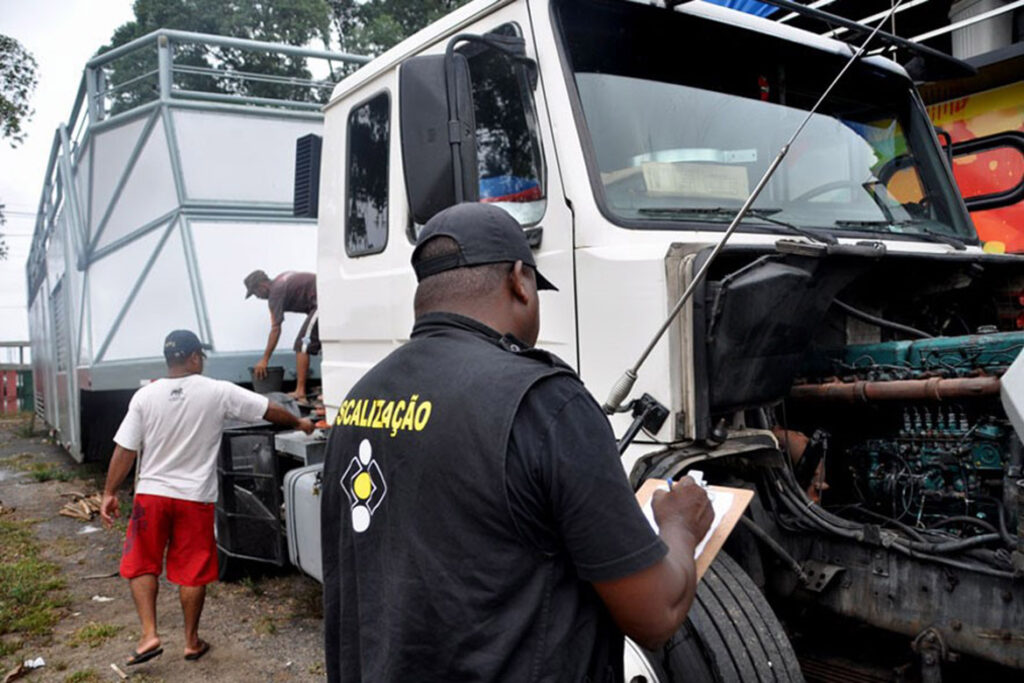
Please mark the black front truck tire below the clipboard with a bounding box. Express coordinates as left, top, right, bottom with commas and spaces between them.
647, 553, 804, 683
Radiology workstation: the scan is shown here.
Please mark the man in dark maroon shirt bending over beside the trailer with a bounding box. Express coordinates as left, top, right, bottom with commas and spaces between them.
244, 270, 321, 400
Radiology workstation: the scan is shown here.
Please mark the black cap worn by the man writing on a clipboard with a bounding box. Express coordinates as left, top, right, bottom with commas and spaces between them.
413, 203, 558, 290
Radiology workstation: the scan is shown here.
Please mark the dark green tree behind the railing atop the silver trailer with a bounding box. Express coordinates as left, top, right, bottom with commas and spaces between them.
99, 0, 331, 114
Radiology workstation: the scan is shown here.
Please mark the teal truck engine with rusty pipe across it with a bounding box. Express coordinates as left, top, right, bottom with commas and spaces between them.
791, 326, 1024, 540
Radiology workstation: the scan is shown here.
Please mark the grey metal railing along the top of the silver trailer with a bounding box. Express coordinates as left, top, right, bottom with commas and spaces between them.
26, 29, 370, 304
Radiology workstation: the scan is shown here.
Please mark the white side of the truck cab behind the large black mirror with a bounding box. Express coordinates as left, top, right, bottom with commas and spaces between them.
317, 3, 579, 409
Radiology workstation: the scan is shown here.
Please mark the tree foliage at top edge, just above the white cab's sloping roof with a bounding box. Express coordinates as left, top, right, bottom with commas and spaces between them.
327, 0, 468, 55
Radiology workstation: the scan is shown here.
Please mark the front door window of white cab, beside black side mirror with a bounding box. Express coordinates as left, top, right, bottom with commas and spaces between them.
460, 24, 547, 225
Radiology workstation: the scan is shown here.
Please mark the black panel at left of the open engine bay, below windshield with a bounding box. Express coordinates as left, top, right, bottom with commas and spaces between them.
706, 254, 870, 413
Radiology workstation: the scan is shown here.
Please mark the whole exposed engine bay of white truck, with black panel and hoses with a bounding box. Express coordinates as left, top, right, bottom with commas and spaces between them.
632, 241, 1024, 667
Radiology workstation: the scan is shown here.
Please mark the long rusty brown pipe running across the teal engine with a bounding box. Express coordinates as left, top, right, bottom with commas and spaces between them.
790, 376, 999, 403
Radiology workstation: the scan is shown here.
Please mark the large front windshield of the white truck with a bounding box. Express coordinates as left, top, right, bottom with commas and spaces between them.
557, 1, 976, 241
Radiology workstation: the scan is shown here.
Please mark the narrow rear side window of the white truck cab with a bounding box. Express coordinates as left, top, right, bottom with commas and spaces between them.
345, 92, 391, 256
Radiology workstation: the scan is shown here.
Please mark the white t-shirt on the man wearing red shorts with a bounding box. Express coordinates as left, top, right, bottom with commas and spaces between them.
114, 375, 269, 503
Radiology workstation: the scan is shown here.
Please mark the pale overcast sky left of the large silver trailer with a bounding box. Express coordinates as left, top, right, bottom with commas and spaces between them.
0, 0, 134, 352
